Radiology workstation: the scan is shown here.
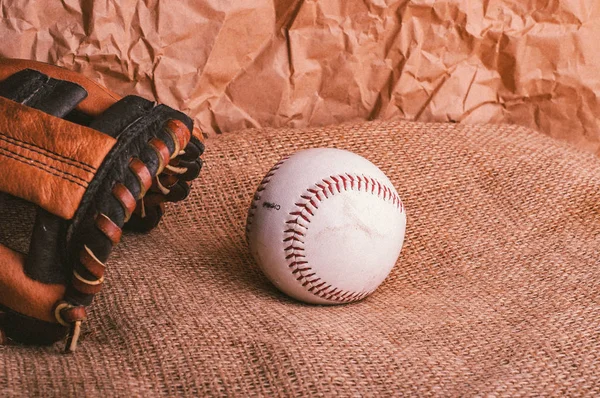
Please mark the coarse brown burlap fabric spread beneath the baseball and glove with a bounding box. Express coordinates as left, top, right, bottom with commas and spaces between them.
0, 122, 600, 397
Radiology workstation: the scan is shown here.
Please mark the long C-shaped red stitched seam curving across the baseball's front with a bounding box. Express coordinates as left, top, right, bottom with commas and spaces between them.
283, 173, 404, 303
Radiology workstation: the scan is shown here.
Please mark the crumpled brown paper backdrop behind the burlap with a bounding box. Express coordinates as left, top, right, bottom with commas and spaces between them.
0, 0, 600, 154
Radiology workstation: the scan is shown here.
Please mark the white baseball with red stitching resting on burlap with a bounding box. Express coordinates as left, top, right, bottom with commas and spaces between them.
246, 148, 406, 304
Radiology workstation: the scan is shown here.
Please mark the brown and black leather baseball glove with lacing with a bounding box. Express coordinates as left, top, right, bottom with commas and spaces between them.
0, 60, 204, 351
